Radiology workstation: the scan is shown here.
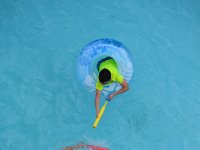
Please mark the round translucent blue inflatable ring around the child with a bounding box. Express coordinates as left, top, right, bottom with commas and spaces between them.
77, 39, 134, 95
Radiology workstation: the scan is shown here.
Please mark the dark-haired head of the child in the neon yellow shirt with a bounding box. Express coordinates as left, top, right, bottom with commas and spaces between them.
99, 68, 111, 84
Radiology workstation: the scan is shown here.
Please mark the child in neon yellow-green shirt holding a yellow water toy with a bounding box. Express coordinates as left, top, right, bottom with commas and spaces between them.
95, 57, 128, 117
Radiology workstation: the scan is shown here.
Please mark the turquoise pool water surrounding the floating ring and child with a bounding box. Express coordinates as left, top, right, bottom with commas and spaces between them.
0, 0, 200, 150
